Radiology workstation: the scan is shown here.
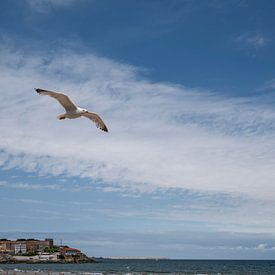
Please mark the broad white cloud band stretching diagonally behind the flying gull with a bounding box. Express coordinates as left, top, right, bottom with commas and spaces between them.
0, 44, 275, 204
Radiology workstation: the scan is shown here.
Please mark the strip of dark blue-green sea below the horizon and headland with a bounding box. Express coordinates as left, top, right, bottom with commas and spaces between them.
0, 259, 275, 275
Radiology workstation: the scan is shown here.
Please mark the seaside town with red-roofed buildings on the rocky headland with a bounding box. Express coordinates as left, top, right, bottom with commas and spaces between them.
0, 239, 95, 263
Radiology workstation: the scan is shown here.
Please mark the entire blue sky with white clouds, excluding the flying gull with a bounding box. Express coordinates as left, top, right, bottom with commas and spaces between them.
0, 0, 275, 259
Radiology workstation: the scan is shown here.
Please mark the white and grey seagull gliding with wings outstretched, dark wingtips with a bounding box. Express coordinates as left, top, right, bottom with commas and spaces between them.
34, 88, 108, 132
